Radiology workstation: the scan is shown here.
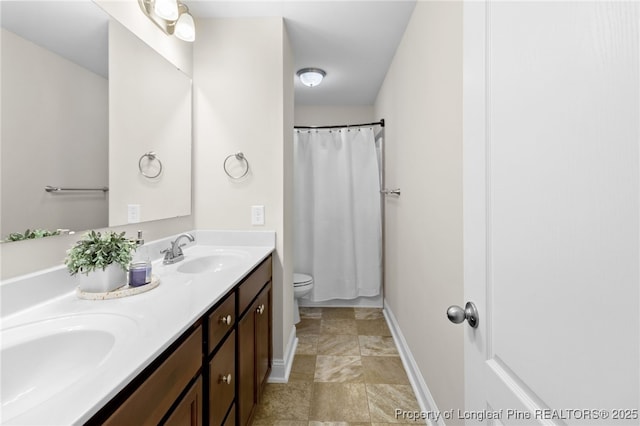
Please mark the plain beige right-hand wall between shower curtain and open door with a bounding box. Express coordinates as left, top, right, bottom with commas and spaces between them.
375, 1, 464, 423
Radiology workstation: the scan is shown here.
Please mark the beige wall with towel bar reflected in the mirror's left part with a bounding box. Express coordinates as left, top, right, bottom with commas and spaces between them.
0, 29, 108, 239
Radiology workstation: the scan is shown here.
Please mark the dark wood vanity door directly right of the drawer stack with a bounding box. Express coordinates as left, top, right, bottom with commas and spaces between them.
236, 303, 257, 426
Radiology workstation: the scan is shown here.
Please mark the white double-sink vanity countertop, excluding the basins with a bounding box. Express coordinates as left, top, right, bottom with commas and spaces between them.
2, 231, 275, 425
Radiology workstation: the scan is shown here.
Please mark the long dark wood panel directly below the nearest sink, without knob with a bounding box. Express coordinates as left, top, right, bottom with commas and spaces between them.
104, 327, 202, 426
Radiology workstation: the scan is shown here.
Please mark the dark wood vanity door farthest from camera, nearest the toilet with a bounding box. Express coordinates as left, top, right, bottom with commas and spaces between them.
255, 283, 272, 401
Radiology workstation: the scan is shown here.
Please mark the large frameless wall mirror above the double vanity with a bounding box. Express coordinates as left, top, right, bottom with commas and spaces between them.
0, 0, 192, 240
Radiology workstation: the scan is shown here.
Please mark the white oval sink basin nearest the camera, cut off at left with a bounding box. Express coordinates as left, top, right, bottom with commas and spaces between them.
0, 314, 137, 421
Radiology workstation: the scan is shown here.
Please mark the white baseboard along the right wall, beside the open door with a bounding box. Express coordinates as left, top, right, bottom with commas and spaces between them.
382, 301, 446, 426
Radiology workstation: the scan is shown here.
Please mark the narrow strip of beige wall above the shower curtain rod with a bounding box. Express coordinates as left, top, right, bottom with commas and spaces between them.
295, 105, 376, 126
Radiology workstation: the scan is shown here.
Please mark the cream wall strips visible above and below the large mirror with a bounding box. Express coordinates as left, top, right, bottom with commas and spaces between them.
0, 0, 194, 279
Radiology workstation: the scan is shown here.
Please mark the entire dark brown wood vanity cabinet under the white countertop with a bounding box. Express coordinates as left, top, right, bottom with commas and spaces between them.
87, 256, 273, 426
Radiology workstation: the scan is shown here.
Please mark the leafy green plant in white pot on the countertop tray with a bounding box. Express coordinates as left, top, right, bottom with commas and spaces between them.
64, 231, 136, 293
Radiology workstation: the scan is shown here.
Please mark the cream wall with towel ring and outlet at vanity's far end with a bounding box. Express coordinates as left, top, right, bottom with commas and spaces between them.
193, 18, 293, 366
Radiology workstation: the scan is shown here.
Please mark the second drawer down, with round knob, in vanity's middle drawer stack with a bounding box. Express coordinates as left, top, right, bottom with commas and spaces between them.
209, 331, 236, 426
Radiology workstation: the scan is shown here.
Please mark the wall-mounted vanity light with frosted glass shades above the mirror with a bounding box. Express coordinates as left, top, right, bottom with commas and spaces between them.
138, 0, 196, 41
